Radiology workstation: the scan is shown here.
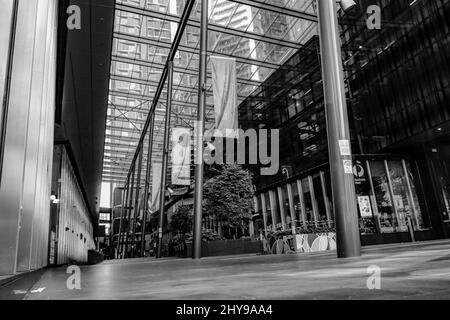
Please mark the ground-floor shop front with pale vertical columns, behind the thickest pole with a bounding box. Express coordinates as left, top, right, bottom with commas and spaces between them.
255, 155, 437, 249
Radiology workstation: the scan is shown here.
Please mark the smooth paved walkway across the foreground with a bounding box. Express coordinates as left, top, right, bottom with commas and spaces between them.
12, 241, 450, 300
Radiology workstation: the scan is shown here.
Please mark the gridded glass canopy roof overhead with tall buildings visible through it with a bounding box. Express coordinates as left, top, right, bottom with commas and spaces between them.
103, 0, 317, 185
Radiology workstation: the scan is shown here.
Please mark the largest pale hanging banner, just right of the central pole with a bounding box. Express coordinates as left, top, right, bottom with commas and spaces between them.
211, 56, 238, 139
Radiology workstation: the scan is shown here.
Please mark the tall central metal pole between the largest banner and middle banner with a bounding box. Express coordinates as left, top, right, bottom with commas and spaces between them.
192, 0, 208, 259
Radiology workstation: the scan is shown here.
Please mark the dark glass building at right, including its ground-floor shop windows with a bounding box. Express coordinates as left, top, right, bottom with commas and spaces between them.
243, 0, 450, 244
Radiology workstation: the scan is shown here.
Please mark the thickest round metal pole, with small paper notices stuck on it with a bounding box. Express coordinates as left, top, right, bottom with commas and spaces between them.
317, 0, 361, 258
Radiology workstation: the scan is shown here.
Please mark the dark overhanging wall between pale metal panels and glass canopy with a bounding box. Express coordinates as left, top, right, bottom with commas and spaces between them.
55, 0, 115, 225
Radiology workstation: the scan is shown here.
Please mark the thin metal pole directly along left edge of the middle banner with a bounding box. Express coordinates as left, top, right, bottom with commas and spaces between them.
156, 61, 173, 258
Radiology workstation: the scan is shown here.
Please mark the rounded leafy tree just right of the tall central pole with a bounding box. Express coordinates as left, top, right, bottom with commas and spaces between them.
203, 164, 254, 227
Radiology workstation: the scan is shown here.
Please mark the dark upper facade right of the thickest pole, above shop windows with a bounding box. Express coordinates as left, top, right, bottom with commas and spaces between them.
342, 0, 450, 153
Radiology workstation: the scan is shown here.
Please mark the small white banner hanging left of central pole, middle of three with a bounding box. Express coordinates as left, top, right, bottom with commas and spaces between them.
171, 128, 192, 186
